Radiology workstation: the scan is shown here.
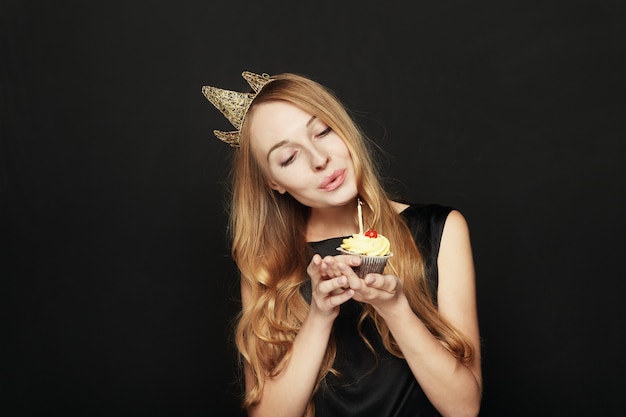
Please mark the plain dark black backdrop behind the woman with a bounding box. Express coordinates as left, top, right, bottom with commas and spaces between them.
0, 0, 626, 417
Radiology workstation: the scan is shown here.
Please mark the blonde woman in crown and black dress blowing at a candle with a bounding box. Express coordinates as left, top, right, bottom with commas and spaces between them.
203, 72, 482, 417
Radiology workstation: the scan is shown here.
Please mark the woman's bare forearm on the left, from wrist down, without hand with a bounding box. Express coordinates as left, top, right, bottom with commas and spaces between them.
248, 312, 332, 417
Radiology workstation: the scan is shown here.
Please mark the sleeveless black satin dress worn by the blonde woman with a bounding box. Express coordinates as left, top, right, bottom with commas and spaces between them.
302, 204, 452, 417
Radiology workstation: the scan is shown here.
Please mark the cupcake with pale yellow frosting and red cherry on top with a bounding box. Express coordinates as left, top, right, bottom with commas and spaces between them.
337, 229, 393, 278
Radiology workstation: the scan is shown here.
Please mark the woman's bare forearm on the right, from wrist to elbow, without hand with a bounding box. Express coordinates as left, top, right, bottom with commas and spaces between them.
379, 297, 482, 416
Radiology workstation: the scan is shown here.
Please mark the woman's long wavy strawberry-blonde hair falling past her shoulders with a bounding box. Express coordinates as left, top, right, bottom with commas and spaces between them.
229, 73, 473, 416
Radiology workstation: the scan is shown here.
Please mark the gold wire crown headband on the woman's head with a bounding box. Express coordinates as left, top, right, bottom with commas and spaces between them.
202, 71, 272, 148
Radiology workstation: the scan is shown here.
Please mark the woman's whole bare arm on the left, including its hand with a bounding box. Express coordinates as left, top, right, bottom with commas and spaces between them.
241, 255, 354, 417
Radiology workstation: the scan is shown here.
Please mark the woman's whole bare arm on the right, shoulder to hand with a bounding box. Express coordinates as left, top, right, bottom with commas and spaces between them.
334, 211, 482, 417
